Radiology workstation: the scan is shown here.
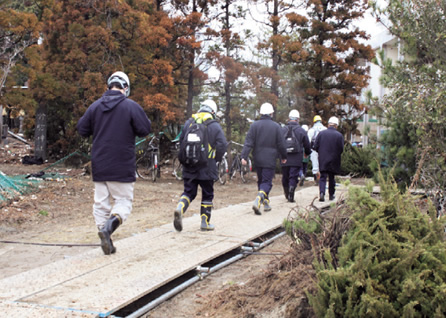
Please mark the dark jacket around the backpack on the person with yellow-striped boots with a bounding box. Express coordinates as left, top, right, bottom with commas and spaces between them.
180, 113, 227, 180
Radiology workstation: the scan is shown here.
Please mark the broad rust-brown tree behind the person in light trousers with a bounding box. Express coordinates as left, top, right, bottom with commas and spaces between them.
24, 0, 177, 155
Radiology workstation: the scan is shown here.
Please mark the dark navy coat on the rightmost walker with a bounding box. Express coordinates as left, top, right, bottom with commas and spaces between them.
314, 126, 344, 174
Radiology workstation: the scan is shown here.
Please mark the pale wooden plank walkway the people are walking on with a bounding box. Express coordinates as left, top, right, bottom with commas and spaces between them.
0, 186, 346, 318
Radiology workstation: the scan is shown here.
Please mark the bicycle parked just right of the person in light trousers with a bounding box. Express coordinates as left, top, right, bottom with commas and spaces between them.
136, 135, 160, 182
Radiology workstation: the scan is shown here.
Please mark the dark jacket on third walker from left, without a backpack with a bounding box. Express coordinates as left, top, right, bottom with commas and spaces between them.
241, 115, 287, 169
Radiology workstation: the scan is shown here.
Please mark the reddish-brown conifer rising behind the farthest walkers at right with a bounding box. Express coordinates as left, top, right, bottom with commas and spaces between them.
285, 0, 374, 132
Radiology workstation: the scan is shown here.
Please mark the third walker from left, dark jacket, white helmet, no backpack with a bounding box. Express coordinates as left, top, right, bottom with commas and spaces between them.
241, 103, 287, 215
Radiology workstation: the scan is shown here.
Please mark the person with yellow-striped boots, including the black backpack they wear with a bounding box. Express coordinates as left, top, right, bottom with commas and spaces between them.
173, 100, 227, 232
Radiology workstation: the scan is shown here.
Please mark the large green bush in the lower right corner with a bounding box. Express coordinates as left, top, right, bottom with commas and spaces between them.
309, 175, 446, 317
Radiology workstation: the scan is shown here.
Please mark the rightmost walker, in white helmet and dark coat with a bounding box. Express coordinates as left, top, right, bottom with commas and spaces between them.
314, 116, 344, 202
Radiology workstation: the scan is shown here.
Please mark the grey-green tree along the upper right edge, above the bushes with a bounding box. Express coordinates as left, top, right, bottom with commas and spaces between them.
375, 0, 446, 206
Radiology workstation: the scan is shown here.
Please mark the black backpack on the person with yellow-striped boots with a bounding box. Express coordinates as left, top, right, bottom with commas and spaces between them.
178, 119, 213, 169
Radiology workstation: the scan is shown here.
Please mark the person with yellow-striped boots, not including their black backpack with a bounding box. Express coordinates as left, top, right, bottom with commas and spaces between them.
173, 99, 227, 232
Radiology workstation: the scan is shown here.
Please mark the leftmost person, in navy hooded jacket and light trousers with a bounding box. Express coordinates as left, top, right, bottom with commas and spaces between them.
77, 72, 151, 255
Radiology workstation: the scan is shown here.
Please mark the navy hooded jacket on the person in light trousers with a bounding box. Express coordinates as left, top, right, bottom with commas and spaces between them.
76, 90, 151, 182
